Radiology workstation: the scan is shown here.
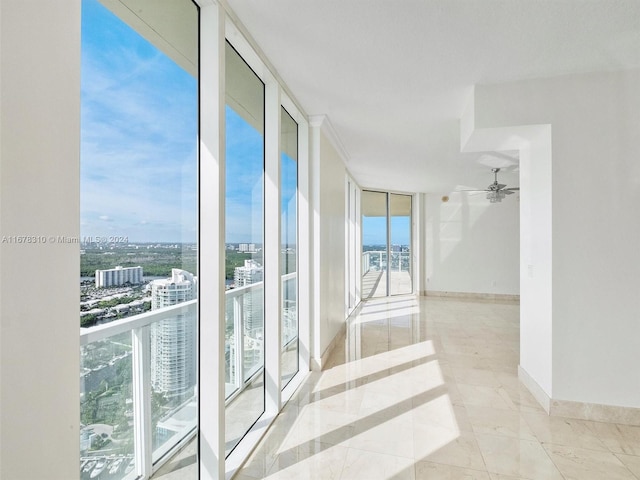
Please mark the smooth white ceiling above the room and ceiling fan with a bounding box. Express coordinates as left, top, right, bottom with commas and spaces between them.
228, 0, 640, 193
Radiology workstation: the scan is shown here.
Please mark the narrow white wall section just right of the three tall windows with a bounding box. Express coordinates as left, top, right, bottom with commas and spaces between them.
310, 119, 347, 364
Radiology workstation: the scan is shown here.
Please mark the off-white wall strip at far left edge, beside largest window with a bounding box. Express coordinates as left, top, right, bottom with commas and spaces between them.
0, 0, 80, 480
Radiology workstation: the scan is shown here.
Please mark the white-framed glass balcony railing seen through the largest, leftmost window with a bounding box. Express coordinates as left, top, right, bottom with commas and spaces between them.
80, 300, 197, 480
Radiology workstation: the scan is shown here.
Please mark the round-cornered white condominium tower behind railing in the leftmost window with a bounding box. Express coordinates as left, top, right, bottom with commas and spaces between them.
151, 268, 197, 397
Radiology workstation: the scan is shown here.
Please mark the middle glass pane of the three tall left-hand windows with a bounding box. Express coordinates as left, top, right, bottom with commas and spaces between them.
225, 43, 264, 454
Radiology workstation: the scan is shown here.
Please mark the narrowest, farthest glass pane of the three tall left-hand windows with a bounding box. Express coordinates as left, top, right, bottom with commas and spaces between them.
280, 108, 298, 388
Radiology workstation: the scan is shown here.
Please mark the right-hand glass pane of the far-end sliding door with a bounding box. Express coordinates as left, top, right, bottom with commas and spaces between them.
389, 193, 413, 295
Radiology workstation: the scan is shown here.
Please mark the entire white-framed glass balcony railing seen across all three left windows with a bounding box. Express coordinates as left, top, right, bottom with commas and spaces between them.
80, 273, 298, 480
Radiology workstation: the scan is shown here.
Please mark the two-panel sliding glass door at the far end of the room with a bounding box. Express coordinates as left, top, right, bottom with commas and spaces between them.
361, 190, 413, 300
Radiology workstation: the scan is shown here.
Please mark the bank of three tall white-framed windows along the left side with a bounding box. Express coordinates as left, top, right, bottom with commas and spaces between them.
80, 0, 310, 480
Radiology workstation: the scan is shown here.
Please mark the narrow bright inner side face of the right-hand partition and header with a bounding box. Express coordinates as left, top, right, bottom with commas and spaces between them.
461, 118, 553, 404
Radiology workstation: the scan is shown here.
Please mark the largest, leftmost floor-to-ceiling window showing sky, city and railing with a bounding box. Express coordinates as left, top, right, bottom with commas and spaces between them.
79, 0, 198, 480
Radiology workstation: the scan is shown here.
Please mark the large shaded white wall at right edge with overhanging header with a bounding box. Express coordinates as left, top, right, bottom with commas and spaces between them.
475, 71, 640, 407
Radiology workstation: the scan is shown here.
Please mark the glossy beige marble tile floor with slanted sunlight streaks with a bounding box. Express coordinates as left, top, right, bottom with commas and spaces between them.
154, 296, 640, 480
